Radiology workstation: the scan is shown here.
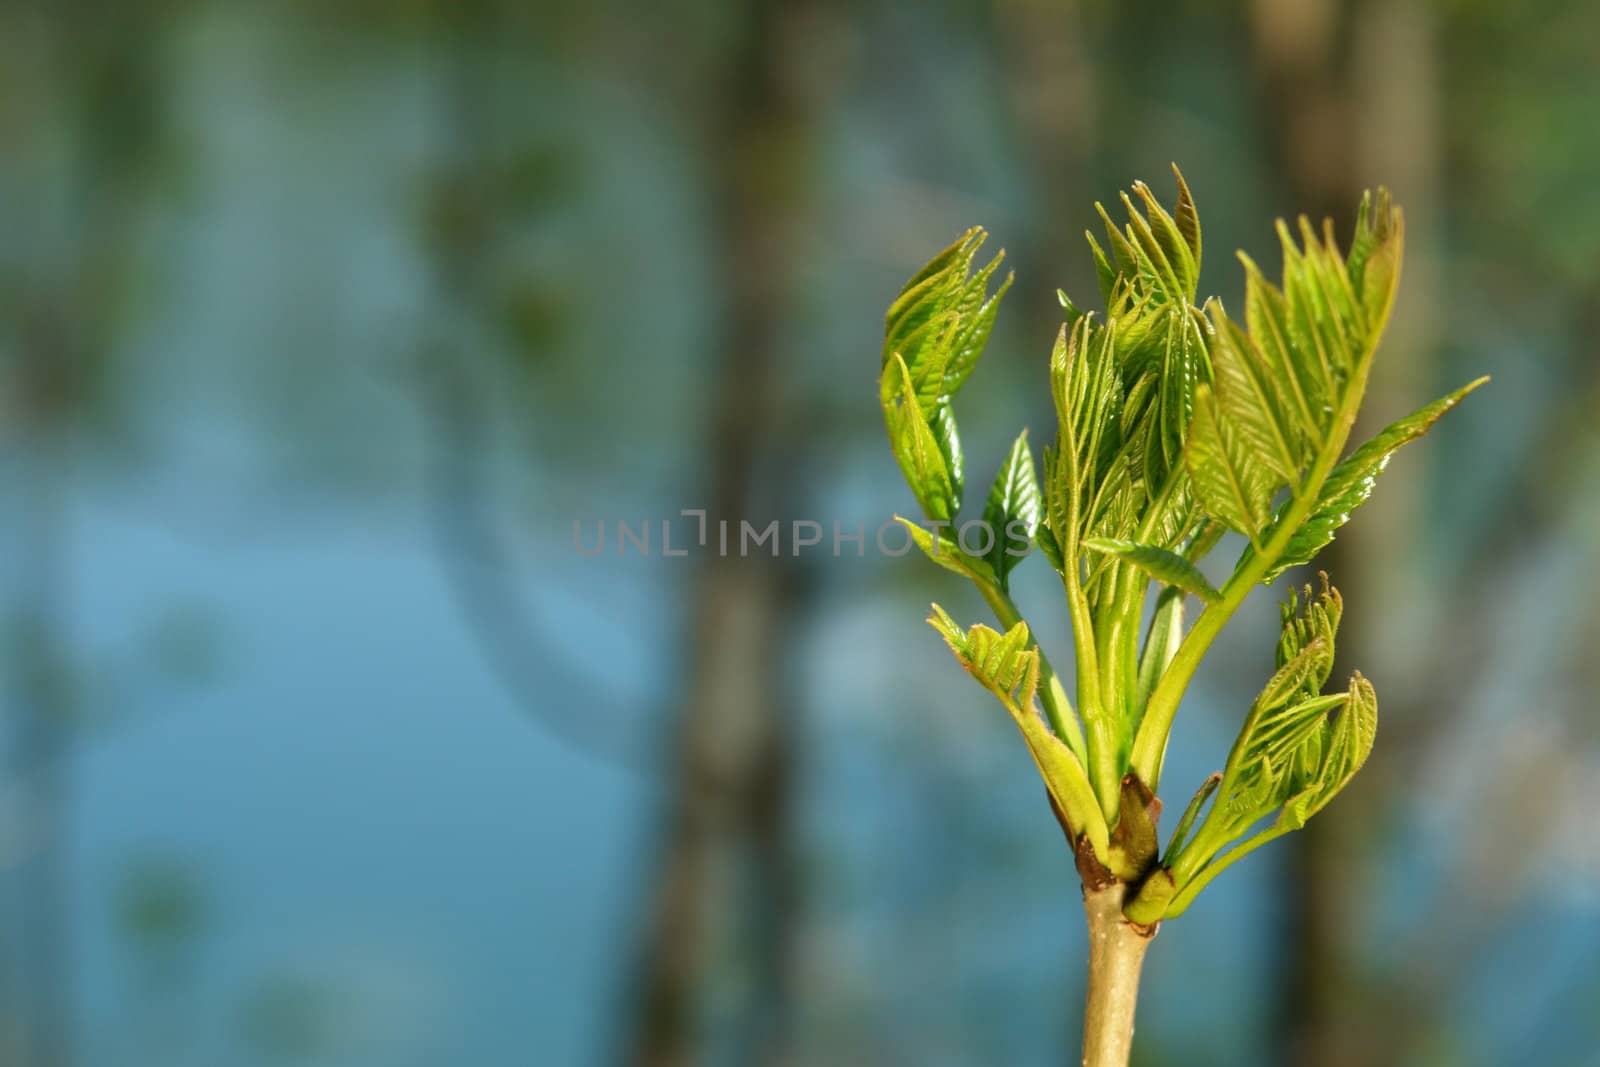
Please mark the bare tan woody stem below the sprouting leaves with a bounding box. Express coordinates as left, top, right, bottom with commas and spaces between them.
1083, 883, 1155, 1067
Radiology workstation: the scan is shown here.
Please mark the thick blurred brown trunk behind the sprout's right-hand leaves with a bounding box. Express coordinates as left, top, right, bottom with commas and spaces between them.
1251, 0, 1438, 1067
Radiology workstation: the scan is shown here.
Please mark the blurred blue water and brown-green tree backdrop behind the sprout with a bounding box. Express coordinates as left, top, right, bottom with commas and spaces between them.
0, 0, 1600, 1067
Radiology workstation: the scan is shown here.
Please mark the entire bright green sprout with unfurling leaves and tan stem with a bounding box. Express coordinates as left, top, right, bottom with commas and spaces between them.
880, 166, 1486, 1067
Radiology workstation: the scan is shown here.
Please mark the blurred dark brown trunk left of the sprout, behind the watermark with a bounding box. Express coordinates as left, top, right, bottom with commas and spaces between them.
627, 0, 822, 1067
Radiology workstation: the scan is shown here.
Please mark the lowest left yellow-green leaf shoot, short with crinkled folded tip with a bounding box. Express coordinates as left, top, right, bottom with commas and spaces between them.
928, 605, 1110, 856
